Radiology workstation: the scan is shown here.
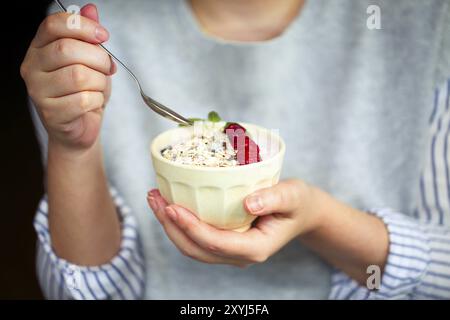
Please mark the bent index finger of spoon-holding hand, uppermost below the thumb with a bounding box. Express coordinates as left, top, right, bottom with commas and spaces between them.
32, 13, 109, 48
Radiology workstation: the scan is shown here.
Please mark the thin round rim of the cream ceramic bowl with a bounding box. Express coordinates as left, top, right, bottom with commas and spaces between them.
150, 122, 286, 172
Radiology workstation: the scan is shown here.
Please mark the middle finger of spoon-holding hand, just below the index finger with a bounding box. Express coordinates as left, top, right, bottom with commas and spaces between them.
37, 38, 115, 75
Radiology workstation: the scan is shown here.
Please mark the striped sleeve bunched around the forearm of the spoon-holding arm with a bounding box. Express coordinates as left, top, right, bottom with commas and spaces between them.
34, 189, 145, 300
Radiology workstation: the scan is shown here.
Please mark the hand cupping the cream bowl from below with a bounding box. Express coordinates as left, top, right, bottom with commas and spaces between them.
147, 180, 321, 267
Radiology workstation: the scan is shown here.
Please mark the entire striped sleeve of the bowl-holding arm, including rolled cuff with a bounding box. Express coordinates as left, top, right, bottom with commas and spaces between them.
329, 79, 450, 299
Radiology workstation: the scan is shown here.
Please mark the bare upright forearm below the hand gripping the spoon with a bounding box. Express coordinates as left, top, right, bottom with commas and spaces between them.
47, 142, 121, 265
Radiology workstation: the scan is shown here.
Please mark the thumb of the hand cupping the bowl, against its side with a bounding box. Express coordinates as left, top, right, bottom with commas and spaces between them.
244, 181, 302, 215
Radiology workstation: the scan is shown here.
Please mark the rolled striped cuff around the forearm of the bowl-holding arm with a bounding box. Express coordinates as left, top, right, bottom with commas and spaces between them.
330, 209, 430, 299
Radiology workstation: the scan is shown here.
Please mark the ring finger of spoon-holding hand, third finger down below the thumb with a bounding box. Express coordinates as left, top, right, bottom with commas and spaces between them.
43, 64, 108, 98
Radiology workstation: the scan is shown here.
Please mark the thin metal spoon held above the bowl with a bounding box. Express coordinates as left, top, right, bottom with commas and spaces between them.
55, 0, 193, 126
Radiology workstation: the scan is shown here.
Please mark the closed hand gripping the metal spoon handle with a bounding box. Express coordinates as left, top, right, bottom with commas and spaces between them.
20, 5, 116, 150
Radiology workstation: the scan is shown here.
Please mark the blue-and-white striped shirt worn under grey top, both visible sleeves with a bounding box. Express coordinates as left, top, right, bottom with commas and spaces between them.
34, 79, 450, 299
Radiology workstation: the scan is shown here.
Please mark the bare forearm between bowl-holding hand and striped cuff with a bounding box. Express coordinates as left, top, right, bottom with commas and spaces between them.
300, 189, 389, 284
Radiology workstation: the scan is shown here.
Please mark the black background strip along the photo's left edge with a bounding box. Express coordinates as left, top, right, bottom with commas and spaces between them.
0, 0, 50, 299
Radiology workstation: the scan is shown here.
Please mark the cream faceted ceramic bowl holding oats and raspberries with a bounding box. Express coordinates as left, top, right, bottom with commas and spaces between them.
151, 124, 285, 232
